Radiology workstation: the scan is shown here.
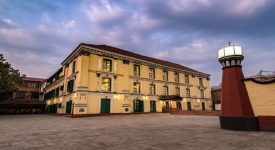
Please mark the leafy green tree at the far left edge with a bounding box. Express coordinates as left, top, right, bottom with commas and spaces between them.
0, 54, 25, 100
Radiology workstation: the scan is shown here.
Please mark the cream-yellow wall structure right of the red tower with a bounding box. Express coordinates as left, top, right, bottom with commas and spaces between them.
244, 71, 275, 116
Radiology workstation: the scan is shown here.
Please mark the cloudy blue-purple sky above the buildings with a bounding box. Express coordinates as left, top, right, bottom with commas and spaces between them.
0, 0, 275, 86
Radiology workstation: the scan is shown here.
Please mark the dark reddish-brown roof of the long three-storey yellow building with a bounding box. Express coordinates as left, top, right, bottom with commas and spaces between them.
62, 43, 210, 76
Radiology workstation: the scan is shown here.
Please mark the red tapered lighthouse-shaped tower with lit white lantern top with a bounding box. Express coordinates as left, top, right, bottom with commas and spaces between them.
219, 43, 258, 131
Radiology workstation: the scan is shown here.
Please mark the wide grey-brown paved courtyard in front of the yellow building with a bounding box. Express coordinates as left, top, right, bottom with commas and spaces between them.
0, 114, 275, 150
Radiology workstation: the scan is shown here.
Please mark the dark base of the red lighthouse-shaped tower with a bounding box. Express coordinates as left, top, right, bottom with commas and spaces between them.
220, 116, 259, 131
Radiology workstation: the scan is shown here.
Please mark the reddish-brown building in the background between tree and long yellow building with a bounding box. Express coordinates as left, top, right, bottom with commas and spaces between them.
12, 77, 45, 101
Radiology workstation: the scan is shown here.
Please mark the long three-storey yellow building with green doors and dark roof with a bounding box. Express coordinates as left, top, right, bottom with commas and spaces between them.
44, 43, 212, 117
